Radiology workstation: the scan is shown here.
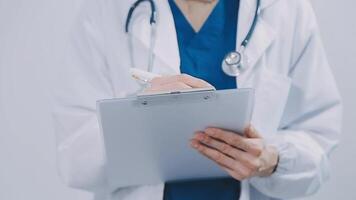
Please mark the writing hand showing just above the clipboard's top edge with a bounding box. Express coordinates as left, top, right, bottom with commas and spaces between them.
151, 74, 213, 88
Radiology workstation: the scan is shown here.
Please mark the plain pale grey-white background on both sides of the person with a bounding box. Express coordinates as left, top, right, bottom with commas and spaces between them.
0, 0, 356, 200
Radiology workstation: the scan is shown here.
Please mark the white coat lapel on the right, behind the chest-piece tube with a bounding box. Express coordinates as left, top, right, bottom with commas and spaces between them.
237, 0, 276, 86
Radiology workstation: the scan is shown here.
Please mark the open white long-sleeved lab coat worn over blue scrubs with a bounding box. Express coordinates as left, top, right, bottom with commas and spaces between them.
53, 0, 341, 200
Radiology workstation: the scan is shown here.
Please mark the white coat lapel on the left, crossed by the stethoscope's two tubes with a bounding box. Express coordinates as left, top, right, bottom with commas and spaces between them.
132, 1, 180, 73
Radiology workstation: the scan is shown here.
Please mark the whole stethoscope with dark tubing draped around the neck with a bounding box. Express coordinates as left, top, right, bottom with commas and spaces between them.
125, 0, 261, 77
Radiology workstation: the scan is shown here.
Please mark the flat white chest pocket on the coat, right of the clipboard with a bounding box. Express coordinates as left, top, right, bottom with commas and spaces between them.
252, 68, 292, 137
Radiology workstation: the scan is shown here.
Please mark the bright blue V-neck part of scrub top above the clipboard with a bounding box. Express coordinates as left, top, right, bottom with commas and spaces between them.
168, 0, 239, 90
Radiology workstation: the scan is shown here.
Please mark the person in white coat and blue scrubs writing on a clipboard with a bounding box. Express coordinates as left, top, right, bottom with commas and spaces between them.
53, 0, 341, 200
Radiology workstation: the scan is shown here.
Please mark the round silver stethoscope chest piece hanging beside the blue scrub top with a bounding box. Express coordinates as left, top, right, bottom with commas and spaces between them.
221, 51, 244, 77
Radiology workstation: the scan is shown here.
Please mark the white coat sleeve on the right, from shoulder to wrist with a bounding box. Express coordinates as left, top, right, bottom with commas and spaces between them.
250, 0, 342, 199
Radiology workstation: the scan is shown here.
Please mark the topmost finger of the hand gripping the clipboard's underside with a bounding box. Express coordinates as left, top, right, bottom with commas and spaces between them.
204, 128, 249, 151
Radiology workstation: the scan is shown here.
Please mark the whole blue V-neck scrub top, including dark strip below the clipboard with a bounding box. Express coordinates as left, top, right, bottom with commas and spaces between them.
164, 0, 241, 200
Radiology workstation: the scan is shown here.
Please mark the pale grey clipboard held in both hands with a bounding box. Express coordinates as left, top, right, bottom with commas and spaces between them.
97, 89, 254, 191
